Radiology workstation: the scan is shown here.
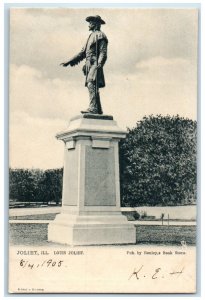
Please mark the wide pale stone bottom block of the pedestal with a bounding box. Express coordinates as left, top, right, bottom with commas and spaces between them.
48, 214, 136, 246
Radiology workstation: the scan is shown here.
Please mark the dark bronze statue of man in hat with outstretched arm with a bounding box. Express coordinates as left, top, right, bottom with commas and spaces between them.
61, 16, 108, 114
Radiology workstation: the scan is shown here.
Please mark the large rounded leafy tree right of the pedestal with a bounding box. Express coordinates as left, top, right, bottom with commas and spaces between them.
120, 115, 196, 206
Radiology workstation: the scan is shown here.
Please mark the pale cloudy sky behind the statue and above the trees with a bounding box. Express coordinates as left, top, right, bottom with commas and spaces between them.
10, 8, 198, 169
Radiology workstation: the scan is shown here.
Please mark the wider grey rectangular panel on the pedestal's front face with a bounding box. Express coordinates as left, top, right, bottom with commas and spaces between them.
85, 146, 116, 206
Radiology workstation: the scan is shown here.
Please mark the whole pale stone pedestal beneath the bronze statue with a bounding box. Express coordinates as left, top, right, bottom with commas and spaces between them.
48, 114, 136, 245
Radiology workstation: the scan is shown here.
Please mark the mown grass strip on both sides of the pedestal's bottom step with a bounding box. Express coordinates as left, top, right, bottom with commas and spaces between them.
9, 223, 196, 246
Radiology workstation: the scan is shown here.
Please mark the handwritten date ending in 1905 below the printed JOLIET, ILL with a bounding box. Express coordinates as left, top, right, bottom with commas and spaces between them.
19, 259, 65, 270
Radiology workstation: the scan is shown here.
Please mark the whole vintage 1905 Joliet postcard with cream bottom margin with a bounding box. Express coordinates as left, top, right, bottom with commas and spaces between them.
8, 7, 199, 294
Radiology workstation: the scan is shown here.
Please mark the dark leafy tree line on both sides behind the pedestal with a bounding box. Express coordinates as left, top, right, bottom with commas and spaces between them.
9, 115, 197, 207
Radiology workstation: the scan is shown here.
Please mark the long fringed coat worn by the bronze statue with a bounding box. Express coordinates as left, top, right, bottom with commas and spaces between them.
69, 30, 108, 88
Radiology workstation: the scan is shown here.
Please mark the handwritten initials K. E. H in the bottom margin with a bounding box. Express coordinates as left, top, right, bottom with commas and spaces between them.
128, 265, 184, 280
